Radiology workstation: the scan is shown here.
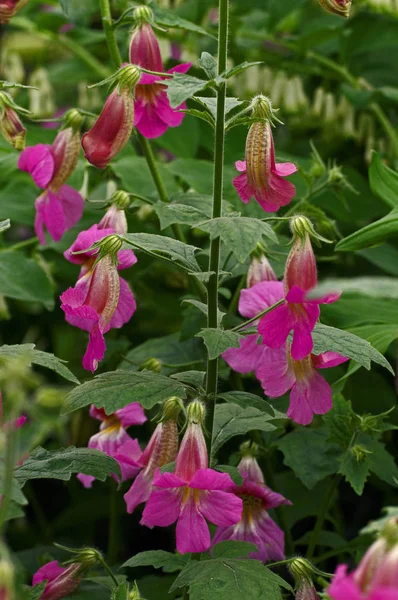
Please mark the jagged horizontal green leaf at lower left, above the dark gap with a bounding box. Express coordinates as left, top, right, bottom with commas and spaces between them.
15, 446, 122, 486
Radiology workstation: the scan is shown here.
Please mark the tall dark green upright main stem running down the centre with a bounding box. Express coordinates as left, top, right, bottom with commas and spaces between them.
206, 0, 229, 452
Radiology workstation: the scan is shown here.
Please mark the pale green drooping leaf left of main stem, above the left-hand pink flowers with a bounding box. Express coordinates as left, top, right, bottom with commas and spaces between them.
122, 233, 200, 271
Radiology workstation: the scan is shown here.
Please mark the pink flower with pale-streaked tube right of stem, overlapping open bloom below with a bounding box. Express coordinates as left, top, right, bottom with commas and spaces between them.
258, 234, 340, 360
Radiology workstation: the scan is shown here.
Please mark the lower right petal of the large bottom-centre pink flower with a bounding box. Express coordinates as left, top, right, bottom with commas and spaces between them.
200, 490, 243, 527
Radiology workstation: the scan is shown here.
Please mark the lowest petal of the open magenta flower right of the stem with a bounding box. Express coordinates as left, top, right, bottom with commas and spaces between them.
287, 371, 333, 425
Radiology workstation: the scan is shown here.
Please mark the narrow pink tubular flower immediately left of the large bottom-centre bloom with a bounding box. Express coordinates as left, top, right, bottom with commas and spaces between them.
124, 419, 178, 513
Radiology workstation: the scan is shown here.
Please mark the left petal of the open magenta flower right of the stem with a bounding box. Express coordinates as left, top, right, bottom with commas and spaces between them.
256, 345, 296, 398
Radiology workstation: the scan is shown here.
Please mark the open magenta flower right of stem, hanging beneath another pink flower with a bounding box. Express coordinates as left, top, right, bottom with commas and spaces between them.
256, 344, 348, 425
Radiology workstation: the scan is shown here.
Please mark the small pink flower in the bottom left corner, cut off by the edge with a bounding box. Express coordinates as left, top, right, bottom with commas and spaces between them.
32, 561, 82, 600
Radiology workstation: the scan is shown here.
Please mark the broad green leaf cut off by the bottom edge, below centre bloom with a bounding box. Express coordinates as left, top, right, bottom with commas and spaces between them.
170, 557, 291, 600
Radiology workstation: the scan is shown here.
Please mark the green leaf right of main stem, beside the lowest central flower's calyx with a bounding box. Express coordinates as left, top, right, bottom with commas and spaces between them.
212, 404, 275, 456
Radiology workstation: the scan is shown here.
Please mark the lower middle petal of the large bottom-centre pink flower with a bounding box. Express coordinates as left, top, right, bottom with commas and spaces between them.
177, 495, 210, 554
